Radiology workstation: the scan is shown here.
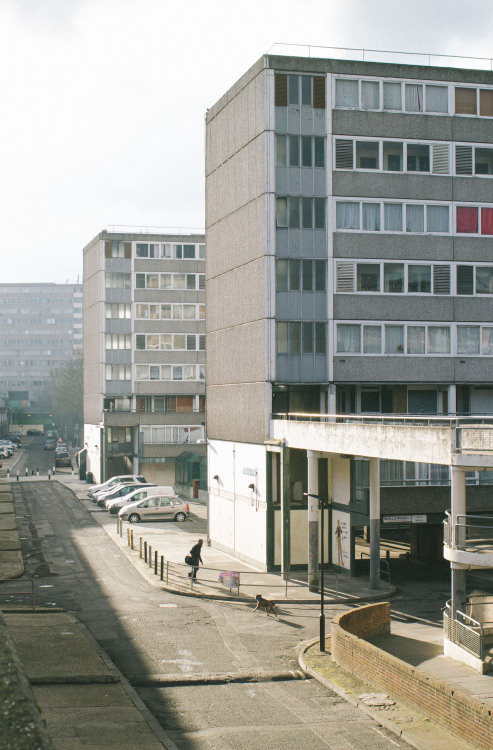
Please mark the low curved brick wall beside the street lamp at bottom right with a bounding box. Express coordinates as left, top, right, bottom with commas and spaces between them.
331, 602, 493, 750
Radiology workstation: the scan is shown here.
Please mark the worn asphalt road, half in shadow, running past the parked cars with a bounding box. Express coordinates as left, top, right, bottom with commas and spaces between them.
10, 445, 409, 750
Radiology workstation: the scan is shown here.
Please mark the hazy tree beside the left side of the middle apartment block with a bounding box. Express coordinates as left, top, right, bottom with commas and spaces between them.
49, 352, 83, 435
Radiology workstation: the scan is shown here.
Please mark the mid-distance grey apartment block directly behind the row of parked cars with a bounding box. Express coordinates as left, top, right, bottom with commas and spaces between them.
84, 231, 205, 492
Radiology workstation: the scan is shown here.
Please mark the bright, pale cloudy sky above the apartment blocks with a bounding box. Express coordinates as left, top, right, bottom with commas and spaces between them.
0, 0, 493, 283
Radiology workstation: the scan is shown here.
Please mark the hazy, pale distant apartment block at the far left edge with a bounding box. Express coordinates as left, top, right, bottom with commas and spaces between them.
0, 283, 82, 409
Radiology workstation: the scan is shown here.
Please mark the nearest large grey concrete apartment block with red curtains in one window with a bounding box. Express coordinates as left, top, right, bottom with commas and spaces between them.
206, 55, 493, 567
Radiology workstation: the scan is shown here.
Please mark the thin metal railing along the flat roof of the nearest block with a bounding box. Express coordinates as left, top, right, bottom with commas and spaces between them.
266, 42, 493, 70
